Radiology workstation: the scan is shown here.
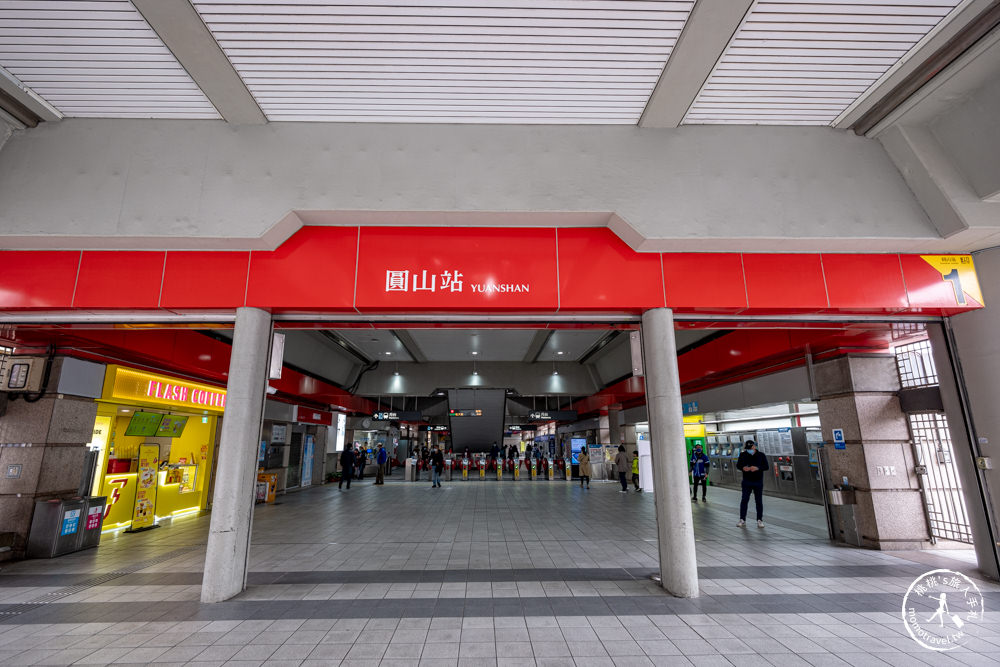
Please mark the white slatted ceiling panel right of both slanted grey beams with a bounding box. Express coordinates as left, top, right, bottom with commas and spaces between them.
684, 0, 961, 125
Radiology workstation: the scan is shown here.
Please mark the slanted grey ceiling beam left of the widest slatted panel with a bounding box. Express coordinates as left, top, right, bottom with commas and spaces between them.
132, 0, 267, 125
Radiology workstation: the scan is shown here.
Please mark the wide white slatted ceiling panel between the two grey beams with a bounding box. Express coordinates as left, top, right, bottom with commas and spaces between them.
194, 0, 694, 124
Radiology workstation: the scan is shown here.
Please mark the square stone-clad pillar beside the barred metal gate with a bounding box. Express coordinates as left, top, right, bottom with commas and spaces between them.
813, 355, 930, 550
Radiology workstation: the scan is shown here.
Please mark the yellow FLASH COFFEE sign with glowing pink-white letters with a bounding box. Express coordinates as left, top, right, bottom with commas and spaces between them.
101, 365, 226, 414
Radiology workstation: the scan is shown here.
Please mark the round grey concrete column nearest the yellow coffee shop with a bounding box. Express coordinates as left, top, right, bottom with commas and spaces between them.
201, 308, 271, 602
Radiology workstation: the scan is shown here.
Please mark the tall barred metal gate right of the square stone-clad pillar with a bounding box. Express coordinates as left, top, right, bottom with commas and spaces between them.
909, 412, 972, 544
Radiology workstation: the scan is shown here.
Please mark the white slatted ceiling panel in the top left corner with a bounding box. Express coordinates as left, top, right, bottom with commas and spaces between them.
0, 0, 219, 118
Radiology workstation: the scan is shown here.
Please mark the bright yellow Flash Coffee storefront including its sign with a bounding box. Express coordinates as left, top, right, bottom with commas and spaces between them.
90, 365, 226, 531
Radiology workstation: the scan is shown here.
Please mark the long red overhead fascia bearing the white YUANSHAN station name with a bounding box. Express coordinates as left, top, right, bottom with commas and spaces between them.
0, 226, 982, 319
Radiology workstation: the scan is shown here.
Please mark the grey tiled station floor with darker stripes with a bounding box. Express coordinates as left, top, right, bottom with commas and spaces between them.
0, 481, 1000, 667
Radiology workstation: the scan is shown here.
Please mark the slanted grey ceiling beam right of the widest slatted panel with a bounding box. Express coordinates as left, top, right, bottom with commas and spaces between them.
639, 0, 754, 127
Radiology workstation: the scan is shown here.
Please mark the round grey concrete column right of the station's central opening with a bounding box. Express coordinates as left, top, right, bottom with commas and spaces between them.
642, 308, 698, 597
